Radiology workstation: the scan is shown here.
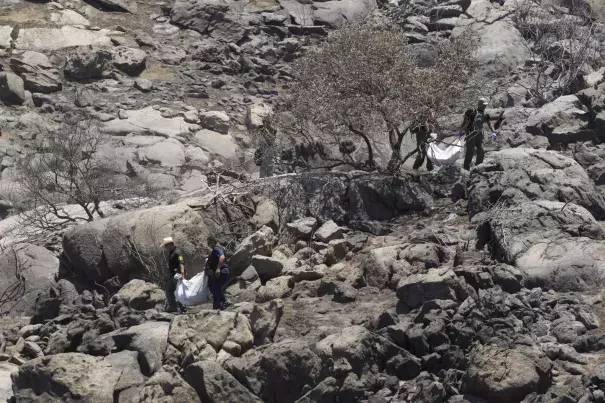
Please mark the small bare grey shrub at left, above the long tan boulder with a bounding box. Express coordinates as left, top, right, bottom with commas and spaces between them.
15, 120, 145, 230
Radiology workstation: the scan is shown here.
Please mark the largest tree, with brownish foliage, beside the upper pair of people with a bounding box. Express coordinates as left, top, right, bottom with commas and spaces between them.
265, 23, 474, 171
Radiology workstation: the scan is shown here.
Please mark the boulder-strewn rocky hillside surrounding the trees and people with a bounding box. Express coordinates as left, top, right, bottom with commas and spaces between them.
0, 0, 605, 403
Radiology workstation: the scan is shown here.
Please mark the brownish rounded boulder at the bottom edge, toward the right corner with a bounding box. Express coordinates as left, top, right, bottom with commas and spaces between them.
461, 345, 551, 403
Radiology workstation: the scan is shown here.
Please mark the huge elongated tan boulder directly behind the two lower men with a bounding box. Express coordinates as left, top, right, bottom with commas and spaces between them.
63, 202, 224, 283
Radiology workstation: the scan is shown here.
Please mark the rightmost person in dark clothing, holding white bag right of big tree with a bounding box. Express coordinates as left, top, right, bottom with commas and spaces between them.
458, 98, 496, 171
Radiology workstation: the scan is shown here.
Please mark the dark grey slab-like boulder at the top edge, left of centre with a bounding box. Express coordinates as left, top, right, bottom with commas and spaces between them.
170, 0, 245, 43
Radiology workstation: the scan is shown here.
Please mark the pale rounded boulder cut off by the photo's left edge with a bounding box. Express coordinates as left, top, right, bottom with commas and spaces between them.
0, 244, 59, 315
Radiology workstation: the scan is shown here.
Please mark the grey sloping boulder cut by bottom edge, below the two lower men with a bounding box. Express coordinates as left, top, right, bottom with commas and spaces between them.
184, 361, 262, 403
